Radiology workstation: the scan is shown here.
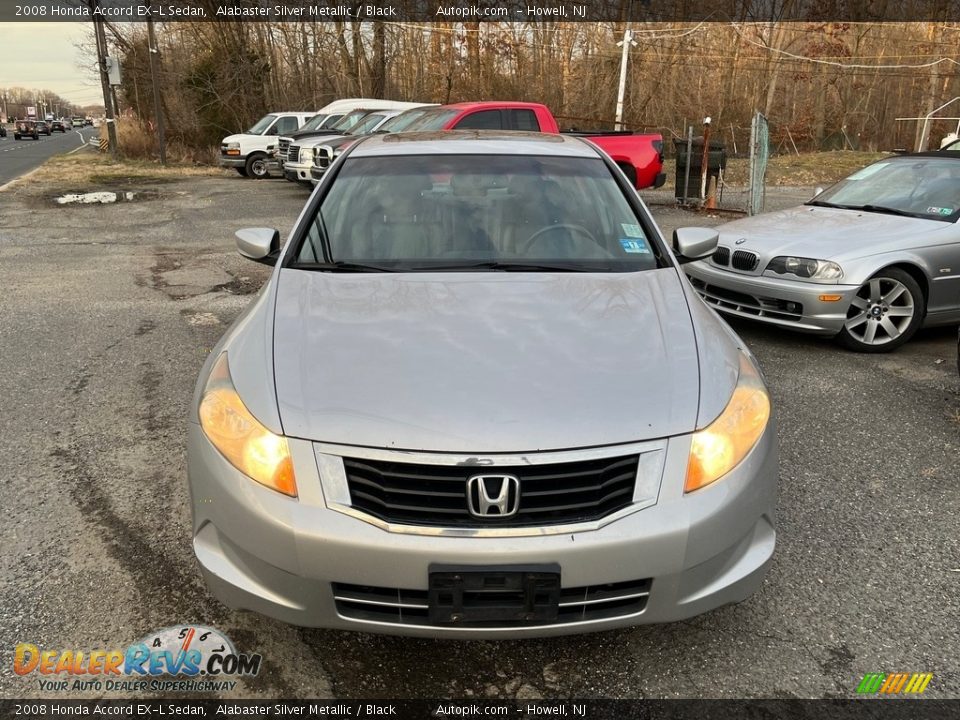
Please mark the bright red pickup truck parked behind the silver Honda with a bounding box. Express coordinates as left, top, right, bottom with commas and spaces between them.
407, 102, 667, 190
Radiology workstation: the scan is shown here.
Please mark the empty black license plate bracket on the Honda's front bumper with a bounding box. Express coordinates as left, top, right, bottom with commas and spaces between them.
428, 565, 560, 627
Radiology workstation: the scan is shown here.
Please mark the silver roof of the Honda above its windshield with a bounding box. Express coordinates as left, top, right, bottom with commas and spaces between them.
351, 130, 600, 158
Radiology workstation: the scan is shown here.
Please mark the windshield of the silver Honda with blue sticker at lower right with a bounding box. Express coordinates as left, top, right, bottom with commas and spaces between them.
296, 155, 663, 272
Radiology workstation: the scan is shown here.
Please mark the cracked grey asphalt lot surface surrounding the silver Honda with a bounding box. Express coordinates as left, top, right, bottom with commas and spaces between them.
0, 172, 960, 699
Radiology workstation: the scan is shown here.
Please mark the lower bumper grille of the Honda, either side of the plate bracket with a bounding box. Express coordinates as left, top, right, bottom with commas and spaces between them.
332, 578, 653, 628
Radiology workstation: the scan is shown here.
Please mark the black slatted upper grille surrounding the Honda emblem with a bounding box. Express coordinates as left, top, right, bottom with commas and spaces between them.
343, 455, 638, 527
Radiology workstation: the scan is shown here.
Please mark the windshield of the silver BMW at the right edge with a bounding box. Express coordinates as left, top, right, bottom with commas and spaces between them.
807, 157, 960, 222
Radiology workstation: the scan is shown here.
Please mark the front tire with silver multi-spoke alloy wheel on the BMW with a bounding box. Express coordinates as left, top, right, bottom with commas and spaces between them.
837, 268, 926, 353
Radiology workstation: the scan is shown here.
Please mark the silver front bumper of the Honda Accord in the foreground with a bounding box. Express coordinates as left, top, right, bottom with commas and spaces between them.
188, 420, 778, 638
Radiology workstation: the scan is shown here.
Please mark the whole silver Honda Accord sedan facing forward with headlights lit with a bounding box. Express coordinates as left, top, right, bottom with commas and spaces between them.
189, 132, 778, 638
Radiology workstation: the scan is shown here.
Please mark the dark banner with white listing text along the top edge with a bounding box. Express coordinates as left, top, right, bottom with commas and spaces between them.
0, 0, 960, 22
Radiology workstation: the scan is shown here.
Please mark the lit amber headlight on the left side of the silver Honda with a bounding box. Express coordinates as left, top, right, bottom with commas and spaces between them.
200, 353, 297, 497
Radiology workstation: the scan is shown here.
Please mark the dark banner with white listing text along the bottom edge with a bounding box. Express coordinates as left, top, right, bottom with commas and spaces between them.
0, 698, 960, 720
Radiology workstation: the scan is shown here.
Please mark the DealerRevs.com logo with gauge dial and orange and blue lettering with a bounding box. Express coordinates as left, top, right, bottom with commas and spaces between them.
13, 625, 262, 692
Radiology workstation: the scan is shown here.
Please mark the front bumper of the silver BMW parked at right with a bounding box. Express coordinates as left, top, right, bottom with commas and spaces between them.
683, 261, 859, 336
